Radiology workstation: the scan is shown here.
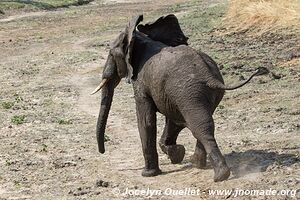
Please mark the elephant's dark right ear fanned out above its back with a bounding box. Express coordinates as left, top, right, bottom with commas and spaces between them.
137, 14, 189, 47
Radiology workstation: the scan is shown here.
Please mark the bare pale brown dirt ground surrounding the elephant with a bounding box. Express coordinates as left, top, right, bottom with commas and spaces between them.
0, 0, 300, 200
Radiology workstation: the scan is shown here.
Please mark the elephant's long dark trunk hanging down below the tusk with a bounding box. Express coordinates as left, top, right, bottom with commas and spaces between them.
96, 80, 114, 153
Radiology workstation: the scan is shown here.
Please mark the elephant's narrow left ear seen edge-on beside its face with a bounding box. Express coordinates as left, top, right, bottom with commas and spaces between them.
124, 15, 143, 82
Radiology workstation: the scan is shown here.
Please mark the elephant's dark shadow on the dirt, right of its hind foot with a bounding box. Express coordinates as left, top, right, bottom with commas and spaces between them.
225, 149, 300, 179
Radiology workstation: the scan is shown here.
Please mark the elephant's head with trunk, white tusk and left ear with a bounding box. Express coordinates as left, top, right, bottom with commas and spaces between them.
92, 15, 143, 153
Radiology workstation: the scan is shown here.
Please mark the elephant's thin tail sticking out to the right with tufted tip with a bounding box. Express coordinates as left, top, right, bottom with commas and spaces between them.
206, 67, 269, 90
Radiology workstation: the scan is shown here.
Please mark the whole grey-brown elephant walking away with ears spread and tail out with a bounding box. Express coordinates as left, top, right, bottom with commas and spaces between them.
92, 14, 269, 182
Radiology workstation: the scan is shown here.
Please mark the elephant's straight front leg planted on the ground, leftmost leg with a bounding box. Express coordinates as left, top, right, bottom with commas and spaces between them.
136, 98, 161, 177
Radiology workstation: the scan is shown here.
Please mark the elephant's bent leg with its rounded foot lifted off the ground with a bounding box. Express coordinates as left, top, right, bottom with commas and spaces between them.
159, 118, 185, 164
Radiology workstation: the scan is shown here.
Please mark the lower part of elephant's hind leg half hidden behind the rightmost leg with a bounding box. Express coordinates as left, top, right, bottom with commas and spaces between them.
191, 140, 207, 169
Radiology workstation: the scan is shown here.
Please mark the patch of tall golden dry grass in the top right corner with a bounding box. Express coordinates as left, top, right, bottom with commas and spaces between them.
223, 0, 300, 34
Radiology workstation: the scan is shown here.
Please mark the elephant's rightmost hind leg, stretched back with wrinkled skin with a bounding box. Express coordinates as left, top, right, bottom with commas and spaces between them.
185, 106, 230, 182
